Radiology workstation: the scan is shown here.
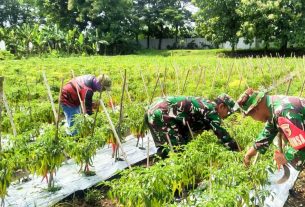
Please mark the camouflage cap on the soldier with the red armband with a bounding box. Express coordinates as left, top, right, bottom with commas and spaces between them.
237, 88, 266, 115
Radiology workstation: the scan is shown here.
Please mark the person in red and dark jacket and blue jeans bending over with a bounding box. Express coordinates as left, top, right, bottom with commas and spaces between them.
60, 75, 111, 135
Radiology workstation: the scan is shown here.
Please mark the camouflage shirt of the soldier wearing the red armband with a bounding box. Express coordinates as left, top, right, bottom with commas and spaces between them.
254, 96, 305, 165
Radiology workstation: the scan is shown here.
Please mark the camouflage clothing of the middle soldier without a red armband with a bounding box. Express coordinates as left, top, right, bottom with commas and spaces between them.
147, 96, 232, 146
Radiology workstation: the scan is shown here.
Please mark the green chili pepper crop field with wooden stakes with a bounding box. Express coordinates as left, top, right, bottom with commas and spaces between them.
0, 50, 305, 207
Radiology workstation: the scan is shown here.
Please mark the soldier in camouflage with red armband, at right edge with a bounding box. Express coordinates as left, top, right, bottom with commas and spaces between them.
237, 88, 305, 168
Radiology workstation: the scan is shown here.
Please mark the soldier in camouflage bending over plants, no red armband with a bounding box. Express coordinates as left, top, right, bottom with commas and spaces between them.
146, 94, 238, 150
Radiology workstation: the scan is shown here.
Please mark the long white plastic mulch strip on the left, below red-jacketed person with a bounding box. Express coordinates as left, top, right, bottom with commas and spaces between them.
5, 136, 157, 207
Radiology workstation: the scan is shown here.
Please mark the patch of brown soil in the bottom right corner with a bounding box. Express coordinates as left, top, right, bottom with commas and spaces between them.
284, 170, 305, 207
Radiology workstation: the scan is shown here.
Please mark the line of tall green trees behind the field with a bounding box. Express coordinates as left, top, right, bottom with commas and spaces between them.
0, 0, 305, 56
